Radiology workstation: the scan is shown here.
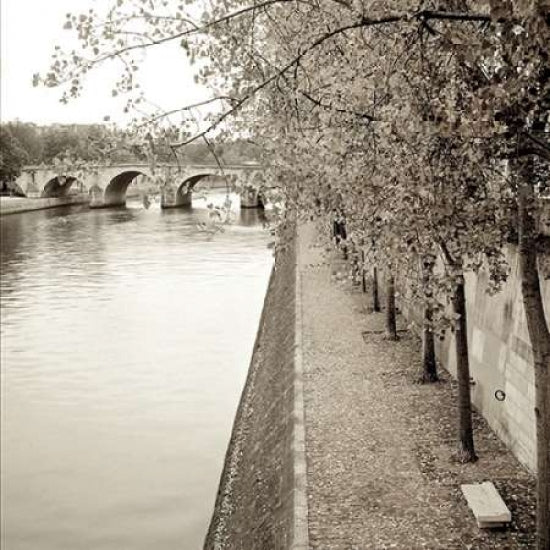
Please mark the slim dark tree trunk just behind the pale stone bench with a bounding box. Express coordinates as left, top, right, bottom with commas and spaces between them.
452, 276, 477, 462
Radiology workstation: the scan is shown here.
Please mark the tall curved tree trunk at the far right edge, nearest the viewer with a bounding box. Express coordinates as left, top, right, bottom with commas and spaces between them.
518, 179, 550, 550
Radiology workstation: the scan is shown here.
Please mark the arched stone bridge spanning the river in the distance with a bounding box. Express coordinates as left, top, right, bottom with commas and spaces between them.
15, 164, 265, 208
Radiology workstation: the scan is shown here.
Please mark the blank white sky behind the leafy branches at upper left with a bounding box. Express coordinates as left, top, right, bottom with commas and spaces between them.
0, 0, 210, 124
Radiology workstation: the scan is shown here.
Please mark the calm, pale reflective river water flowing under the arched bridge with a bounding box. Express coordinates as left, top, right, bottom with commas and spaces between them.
0, 197, 272, 550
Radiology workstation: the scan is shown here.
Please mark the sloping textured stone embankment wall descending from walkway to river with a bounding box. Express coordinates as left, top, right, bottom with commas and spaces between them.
204, 240, 306, 550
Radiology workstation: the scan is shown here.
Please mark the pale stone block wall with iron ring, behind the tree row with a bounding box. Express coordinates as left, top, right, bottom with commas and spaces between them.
402, 246, 550, 471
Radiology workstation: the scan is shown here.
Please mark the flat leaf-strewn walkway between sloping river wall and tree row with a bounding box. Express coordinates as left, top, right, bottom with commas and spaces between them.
298, 224, 534, 550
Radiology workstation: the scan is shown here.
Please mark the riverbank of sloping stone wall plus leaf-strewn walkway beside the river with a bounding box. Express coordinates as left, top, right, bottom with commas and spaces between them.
205, 225, 535, 550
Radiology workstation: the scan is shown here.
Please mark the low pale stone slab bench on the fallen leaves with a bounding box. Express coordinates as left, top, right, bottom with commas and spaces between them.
460, 481, 512, 529
